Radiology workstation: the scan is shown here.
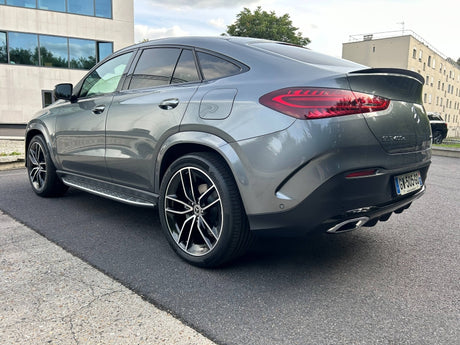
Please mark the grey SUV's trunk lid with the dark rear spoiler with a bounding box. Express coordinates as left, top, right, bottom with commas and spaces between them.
348, 68, 431, 153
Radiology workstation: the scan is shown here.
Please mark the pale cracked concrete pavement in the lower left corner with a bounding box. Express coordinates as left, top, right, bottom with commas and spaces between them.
0, 211, 214, 345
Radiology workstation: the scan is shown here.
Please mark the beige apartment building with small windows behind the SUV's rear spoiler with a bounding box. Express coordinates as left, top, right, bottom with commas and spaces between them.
342, 31, 460, 138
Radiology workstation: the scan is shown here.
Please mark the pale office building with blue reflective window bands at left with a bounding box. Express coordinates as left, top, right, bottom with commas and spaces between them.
0, 0, 134, 124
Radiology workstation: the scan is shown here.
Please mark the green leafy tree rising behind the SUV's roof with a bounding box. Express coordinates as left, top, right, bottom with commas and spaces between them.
226, 6, 310, 46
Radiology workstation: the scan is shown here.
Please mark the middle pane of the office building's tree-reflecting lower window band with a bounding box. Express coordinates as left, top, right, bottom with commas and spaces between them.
39, 35, 69, 67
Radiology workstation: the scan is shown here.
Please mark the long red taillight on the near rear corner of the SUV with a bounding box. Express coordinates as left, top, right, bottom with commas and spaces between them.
259, 87, 390, 120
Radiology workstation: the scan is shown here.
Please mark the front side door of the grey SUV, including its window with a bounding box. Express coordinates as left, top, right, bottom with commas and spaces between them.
56, 52, 133, 179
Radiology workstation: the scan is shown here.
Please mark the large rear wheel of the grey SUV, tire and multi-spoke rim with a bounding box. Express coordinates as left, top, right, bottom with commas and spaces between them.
159, 152, 251, 267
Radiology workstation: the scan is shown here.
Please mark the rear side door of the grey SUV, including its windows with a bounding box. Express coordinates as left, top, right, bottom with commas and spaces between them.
106, 47, 201, 190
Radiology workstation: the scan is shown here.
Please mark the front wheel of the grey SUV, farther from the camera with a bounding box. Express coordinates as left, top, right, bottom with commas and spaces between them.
27, 135, 68, 197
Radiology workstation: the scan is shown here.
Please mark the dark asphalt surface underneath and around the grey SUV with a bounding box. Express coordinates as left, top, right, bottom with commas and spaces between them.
0, 157, 460, 345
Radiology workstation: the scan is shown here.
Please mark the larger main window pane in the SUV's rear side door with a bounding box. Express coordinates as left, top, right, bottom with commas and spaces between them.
129, 48, 181, 89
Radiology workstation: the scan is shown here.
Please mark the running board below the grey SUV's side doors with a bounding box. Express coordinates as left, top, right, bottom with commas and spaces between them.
57, 171, 158, 207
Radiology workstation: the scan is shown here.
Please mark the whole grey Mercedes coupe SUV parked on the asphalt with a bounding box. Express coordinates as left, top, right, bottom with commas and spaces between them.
26, 37, 431, 267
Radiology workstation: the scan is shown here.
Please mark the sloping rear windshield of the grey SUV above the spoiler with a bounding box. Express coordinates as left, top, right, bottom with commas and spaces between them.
251, 42, 362, 67
